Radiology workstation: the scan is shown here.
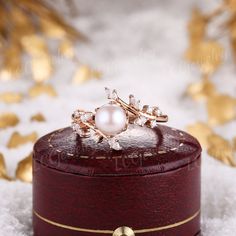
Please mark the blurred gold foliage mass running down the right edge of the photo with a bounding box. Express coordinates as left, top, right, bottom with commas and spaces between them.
185, 0, 236, 167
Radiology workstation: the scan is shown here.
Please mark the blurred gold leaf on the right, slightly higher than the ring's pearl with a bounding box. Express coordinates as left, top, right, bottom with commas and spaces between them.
186, 79, 216, 101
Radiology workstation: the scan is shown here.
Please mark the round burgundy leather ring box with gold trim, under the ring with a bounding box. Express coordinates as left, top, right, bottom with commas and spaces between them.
33, 125, 201, 236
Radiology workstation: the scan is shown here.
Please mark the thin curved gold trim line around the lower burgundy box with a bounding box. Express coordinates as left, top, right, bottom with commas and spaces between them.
34, 210, 200, 235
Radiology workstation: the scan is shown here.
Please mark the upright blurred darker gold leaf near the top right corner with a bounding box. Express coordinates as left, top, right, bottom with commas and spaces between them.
188, 8, 207, 43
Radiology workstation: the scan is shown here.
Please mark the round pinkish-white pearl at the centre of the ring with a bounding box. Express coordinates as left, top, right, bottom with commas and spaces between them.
95, 104, 127, 136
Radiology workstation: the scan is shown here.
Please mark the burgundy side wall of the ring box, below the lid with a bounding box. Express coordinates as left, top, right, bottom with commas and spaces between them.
33, 125, 201, 236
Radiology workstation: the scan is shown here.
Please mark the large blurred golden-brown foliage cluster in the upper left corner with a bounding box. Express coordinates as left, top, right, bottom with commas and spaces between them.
0, 0, 86, 82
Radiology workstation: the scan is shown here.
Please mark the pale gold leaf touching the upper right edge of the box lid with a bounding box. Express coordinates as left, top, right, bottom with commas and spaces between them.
187, 122, 214, 148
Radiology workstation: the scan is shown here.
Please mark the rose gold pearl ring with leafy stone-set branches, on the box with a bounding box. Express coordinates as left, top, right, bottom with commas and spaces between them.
72, 88, 168, 150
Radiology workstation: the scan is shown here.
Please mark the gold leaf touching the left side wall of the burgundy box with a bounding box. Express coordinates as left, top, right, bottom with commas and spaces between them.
16, 154, 32, 183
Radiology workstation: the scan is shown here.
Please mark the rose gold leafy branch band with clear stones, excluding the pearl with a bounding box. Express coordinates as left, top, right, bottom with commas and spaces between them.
72, 88, 168, 150
